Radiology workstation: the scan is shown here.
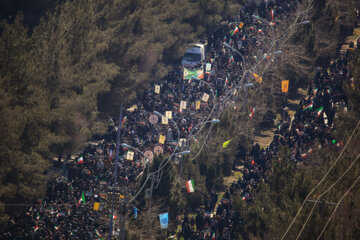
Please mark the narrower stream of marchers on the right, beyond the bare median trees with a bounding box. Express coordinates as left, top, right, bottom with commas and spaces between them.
171, 15, 360, 240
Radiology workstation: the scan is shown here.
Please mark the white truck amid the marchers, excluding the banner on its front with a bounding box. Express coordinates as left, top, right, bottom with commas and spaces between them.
181, 43, 205, 68
